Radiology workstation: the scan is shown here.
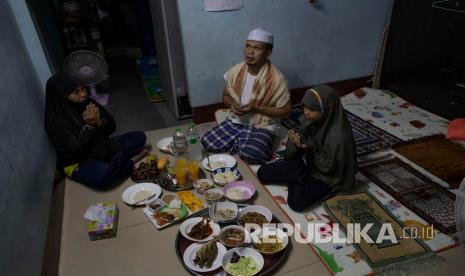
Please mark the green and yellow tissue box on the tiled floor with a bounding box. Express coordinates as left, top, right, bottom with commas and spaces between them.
87, 202, 118, 241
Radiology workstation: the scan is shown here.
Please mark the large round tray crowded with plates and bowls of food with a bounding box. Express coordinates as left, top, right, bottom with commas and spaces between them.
175, 203, 291, 275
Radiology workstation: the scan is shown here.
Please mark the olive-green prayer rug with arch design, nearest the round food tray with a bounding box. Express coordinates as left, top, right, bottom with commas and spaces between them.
324, 192, 433, 272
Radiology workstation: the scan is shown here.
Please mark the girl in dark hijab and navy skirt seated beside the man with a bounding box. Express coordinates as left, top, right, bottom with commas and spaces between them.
258, 86, 357, 211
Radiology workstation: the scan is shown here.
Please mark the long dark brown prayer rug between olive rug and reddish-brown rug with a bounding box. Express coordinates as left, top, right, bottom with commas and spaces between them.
360, 158, 456, 234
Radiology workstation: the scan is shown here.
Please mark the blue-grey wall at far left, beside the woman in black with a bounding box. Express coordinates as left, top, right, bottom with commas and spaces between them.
0, 1, 55, 275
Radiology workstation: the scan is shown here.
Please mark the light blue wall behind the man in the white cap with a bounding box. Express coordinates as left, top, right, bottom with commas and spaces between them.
178, 0, 393, 107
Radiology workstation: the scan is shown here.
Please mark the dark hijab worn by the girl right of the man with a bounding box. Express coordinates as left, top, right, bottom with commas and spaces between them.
301, 85, 357, 191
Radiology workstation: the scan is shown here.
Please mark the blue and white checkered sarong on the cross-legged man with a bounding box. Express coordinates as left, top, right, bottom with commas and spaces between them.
201, 119, 275, 164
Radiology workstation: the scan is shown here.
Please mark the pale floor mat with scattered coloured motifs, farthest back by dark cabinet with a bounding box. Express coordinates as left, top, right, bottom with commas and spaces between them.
341, 88, 449, 141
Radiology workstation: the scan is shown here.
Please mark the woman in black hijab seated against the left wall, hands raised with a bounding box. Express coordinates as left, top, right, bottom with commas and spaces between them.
45, 74, 148, 188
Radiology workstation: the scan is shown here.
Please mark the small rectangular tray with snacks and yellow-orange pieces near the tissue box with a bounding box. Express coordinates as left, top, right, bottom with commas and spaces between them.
142, 191, 207, 229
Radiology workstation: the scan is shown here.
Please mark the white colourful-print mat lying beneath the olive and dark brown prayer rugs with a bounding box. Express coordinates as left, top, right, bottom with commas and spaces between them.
250, 165, 457, 275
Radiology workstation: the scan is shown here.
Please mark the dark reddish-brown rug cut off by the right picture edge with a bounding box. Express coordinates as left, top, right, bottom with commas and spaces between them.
393, 135, 465, 189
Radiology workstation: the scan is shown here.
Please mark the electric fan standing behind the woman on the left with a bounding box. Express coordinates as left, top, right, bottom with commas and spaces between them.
63, 50, 110, 105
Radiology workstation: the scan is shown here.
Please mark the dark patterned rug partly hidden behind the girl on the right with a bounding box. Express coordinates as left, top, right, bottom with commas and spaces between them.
281, 105, 402, 156
